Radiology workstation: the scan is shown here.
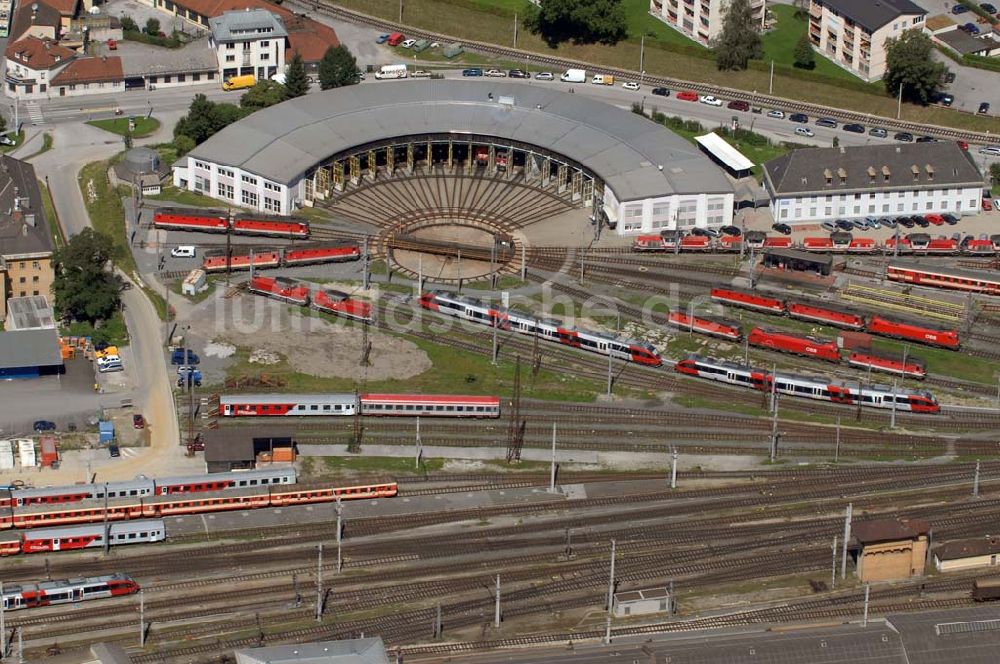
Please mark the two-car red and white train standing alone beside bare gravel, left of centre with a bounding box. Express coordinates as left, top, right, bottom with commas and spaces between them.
219, 394, 500, 418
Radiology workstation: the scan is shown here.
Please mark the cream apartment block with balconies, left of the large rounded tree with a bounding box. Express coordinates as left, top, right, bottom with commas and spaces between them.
809, 0, 927, 81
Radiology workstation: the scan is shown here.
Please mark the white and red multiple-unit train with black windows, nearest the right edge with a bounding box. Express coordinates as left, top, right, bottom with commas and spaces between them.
674, 355, 941, 413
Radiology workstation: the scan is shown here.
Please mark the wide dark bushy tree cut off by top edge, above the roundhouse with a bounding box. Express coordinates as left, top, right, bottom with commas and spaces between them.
524, 0, 628, 46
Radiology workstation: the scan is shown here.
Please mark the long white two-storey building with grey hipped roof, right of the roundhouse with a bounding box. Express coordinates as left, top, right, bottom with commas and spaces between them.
764, 141, 983, 224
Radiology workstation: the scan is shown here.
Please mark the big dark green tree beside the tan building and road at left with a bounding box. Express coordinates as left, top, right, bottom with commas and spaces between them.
52, 228, 121, 323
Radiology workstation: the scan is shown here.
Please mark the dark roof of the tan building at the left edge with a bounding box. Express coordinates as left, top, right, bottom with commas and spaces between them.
0, 155, 52, 259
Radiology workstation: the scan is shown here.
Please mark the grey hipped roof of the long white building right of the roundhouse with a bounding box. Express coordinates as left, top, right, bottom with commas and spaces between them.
764, 141, 983, 196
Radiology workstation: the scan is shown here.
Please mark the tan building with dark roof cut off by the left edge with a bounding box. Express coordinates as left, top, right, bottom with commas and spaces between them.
0, 155, 54, 320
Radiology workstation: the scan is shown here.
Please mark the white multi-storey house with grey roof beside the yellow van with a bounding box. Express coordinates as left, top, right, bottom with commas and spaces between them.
208, 9, 288, 81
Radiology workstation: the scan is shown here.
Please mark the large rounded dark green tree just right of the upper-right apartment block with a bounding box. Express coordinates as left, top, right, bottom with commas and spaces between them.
885, 28, 948, 104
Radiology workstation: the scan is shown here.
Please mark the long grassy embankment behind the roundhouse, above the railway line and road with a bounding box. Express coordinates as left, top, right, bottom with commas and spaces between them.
360, 0, 1000, 132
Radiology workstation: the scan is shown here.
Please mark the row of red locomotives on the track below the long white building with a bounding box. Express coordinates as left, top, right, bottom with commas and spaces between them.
632, 231, 1000, 256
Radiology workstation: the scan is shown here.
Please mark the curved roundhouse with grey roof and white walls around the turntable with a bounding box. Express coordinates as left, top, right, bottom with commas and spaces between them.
174, 80, 734, 235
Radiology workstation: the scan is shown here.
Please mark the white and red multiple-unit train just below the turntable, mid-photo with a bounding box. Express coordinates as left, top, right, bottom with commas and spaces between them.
420, 291, 663, 367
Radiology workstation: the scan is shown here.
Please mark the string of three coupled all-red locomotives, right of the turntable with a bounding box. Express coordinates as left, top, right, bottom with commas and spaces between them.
711, 288, 961, 350
